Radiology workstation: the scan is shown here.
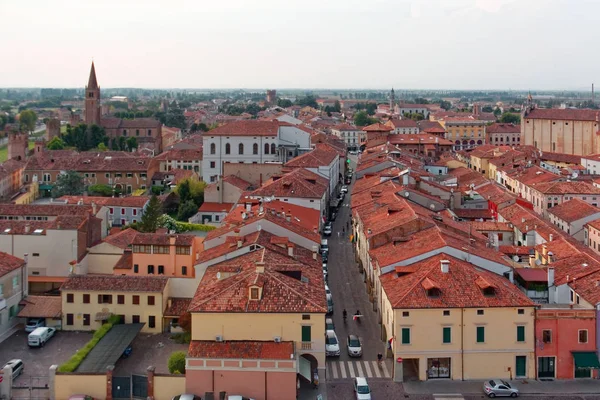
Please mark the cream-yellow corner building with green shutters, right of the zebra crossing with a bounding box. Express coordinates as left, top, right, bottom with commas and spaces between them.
380, 254, 535, 382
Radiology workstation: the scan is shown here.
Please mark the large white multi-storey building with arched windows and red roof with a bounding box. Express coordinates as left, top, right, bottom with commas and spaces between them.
202, 120, 310, 182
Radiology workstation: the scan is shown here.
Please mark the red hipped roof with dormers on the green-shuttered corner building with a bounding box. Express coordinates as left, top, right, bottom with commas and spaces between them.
380, 254, 534, 309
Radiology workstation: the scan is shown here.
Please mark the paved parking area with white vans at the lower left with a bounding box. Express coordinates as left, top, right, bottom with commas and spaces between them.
0, 330, 92, 385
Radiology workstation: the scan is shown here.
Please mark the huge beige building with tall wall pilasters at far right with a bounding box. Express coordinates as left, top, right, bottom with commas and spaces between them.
521, 106, 600, 156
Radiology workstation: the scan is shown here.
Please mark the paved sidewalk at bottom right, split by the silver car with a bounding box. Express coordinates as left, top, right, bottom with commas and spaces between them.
403, 379, 600, 395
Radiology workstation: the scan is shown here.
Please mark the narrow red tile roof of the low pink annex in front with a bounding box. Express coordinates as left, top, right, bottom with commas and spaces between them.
187, 340, 294, 360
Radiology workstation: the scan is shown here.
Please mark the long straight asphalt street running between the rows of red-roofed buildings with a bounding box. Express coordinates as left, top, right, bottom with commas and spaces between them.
327, 157, 391, 381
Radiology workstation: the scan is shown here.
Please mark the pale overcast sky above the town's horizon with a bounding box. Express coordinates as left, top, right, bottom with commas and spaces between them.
0, 0, 600, 90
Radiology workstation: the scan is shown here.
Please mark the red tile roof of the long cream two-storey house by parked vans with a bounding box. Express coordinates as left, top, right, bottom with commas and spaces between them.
60, 275, 169, 292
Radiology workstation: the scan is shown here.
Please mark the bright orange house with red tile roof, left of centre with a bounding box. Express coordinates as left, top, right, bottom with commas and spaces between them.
123, 233, 202, 278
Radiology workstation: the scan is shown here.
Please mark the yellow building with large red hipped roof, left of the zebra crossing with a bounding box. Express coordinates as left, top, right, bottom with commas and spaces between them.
186, 230, 327, 390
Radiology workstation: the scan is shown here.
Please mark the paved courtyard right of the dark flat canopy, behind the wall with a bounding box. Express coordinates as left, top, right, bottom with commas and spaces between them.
114, 333, 189, 376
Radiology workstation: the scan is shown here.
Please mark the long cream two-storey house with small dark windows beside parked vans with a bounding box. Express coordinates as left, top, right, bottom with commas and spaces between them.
61, 275, 169, 333
